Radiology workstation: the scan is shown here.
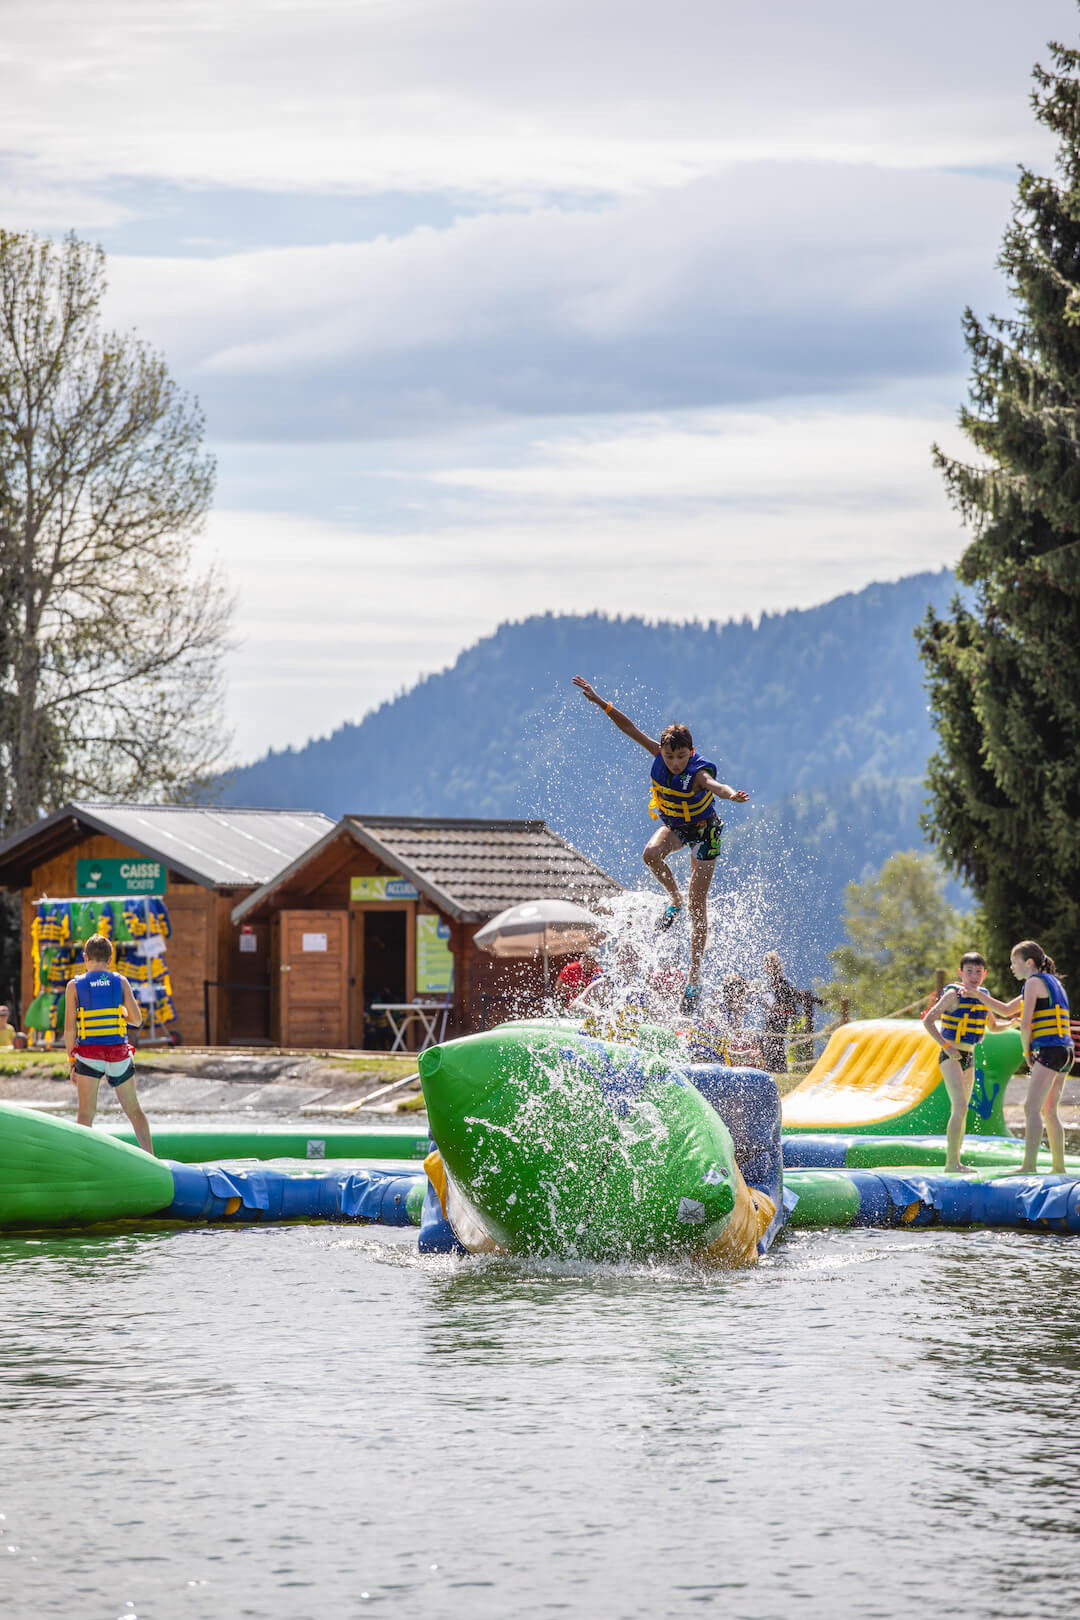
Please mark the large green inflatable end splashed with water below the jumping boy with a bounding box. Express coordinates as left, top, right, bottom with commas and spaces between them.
419, 1024, 746, 1260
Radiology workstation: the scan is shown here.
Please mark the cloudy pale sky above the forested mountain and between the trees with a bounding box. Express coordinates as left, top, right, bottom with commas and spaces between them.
0, 0, 1080, 760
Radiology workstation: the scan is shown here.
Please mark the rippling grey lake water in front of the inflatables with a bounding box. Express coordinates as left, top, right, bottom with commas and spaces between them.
0, 1226, 1080, 1620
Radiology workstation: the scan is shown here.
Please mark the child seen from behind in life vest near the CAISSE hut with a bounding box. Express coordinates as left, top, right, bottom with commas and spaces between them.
63, 933, 154, 1153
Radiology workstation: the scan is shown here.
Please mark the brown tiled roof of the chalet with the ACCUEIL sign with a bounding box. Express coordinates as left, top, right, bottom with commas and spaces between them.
233, 815, 620, 922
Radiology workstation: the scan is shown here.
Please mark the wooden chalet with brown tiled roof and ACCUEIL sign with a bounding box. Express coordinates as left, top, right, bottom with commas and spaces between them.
232, 815, 620, 1048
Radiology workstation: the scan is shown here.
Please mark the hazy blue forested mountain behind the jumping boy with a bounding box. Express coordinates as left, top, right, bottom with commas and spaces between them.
225, 570, 955, 977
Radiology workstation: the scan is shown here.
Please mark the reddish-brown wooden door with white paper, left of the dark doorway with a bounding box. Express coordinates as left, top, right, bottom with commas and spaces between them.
279, 910, 348, 1048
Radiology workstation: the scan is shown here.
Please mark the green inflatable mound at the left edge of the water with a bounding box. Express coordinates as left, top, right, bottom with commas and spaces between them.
0, 1103, 173, 1231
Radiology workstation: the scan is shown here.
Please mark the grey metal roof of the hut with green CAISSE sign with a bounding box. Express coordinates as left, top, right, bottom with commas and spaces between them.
0, 800, 334, 888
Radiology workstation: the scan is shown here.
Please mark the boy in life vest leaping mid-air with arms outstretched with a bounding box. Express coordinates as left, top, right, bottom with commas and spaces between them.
573, 676, 750, 1013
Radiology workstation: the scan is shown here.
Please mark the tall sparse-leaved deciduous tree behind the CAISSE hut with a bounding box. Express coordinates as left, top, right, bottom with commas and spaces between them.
0, 230, 232, 829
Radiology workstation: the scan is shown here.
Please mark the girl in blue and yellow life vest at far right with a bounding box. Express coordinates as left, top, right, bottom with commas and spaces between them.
981, 940, 1075, 1176
